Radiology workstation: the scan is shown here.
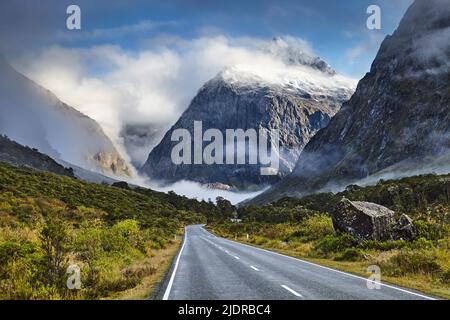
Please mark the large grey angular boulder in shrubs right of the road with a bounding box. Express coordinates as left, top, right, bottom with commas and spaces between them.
331, 198, 395, 241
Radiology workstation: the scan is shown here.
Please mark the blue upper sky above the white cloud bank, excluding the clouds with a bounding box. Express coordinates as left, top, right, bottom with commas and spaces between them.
0, 0, 412, 78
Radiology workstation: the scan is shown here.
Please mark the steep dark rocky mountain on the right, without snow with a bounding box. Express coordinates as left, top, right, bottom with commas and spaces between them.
249, 0, 450, 203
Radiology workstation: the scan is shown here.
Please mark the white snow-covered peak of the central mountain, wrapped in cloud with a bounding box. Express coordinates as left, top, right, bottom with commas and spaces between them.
207, 37, 357, 97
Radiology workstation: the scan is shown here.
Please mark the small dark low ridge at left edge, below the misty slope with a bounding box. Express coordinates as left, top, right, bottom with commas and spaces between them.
0, 135, 74, 177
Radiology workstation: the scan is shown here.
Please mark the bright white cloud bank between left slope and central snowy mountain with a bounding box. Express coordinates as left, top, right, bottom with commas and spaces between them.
16, 35, 326, 161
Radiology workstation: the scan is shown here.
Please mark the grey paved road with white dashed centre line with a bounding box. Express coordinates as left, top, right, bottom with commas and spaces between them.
163, 225, 431, 300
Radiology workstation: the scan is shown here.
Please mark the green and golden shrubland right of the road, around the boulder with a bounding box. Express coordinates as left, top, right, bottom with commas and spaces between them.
210, 175, 450, 298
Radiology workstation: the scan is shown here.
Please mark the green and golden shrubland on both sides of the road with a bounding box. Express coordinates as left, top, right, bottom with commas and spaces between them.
0, 163, 450, 299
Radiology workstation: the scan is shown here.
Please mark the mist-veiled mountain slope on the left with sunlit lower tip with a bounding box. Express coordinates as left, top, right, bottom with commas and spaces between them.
0, 56, 130, 176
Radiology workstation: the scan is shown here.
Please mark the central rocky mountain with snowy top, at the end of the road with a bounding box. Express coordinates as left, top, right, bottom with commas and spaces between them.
141, 38, 355, 189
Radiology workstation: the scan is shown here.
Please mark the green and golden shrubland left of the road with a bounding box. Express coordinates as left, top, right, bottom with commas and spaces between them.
0, 163, 230, 299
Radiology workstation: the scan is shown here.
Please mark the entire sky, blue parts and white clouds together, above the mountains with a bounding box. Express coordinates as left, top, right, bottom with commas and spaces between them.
0, 0, 412, 202
